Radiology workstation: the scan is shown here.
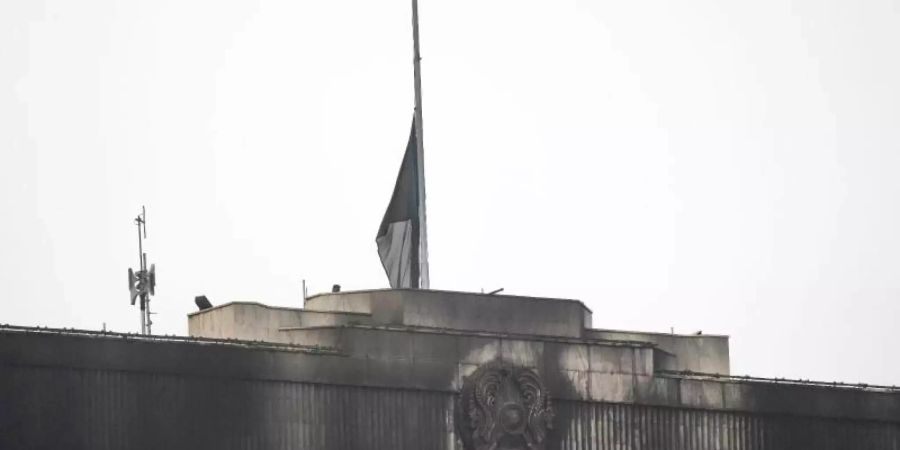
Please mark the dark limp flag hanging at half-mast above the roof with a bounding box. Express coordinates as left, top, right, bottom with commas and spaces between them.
375, 119, 428, 289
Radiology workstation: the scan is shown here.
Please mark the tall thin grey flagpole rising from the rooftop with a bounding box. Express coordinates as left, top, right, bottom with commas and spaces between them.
412, 0, 430, 289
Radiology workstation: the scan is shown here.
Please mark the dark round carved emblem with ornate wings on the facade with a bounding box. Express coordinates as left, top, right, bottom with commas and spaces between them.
456, 362, 553, 450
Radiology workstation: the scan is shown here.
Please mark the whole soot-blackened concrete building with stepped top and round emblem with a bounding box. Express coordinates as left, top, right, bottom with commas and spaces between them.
0, 290, 900, 450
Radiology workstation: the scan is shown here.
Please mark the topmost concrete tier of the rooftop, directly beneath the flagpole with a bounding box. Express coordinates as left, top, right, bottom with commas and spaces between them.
306, 289, 591, 337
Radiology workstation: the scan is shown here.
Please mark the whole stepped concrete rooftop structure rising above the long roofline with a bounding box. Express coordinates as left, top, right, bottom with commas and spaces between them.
188, 290, 729, 374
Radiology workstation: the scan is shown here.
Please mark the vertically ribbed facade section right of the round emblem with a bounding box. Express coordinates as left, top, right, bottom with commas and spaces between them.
550, 402, 900, 450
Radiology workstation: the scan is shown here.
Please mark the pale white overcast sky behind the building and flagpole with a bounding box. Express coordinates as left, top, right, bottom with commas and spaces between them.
0, 0, 900, 384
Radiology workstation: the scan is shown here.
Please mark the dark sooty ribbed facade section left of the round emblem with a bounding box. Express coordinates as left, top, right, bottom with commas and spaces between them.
0, 366, 457, 450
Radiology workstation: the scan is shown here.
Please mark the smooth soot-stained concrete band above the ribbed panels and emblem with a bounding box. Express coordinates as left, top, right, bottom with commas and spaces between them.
0, 328, 900, 422
